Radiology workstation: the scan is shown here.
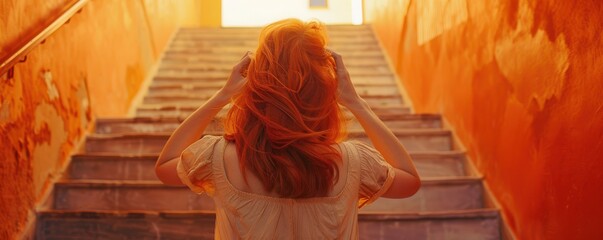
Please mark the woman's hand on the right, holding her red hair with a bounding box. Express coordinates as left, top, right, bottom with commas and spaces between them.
329, 50, 362, 108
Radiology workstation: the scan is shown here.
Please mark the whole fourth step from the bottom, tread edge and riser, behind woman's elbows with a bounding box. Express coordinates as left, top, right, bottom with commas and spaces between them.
85, 129, 452, 154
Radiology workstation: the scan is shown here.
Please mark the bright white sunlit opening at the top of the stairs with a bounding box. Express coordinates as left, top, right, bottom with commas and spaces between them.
221, 0, 363, 27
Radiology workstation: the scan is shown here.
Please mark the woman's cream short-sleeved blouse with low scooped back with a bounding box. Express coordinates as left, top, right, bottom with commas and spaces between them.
178, 136, 394, 239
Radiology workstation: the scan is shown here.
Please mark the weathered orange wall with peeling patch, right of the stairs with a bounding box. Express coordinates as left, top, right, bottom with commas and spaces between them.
365, 0, 603, 240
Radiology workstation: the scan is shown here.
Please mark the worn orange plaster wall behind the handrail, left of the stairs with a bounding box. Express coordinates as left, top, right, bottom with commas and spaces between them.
0, 0, 193, 239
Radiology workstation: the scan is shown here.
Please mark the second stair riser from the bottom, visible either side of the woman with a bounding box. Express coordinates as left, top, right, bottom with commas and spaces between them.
53, 177, 483, 213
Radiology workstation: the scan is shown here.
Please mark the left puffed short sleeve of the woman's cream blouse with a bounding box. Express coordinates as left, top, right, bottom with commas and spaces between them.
176, 135, 222, 196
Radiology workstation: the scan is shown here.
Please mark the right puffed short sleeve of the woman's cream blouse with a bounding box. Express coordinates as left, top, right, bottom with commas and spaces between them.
353, 141, 395, 208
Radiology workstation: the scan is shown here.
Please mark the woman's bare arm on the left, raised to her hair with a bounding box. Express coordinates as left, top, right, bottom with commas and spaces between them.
155, 52, 251, 185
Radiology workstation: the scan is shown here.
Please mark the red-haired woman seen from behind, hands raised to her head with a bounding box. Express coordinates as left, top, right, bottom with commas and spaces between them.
156, 19, 421, 239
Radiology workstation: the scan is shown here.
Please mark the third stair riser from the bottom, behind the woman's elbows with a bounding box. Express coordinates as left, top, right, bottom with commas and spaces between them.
67, 154, 465, 180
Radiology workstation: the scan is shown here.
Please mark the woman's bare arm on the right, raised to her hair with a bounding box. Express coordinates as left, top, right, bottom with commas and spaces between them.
331, 52, 421, 198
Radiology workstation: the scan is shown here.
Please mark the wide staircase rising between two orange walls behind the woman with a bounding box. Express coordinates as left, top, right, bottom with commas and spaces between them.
36, 26, 500, 240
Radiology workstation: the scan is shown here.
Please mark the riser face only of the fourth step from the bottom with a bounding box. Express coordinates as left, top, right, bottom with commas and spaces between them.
86, 134, 451, 154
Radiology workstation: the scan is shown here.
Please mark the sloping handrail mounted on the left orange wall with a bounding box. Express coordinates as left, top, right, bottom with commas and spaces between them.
0, 0, 90, 76
